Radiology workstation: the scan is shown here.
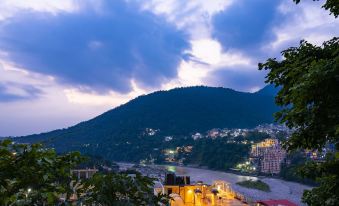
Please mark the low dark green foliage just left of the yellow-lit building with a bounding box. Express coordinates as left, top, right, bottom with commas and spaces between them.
81, 173, 169, 206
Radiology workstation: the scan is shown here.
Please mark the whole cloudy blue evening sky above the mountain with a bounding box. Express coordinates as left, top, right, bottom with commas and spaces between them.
0, 0, 339, 136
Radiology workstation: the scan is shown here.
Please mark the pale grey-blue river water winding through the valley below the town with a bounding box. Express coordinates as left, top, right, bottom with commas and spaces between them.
119, 163, 311, 205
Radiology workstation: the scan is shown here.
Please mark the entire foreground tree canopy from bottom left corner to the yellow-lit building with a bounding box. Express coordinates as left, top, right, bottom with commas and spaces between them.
0, 140, 168, 206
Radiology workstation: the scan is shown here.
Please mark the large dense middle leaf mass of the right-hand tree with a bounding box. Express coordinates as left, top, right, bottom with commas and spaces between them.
259, 38, 339, 150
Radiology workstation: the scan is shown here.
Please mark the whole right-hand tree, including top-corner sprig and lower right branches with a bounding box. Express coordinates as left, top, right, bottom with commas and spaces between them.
259, 0, 339, 205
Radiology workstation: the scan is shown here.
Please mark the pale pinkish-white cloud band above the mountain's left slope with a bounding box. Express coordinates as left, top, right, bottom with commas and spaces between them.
0, 61, 141, 136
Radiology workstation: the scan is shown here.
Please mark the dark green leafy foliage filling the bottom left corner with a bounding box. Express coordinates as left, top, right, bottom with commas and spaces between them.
0, 140, 82, 205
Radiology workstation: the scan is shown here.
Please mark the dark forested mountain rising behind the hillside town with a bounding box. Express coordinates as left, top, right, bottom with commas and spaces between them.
17, 86, 277, 160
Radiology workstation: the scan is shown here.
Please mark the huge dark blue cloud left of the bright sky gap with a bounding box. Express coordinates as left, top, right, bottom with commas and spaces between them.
0, 1, 190, 93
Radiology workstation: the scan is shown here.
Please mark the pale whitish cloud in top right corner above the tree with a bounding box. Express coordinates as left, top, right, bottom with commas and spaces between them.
263, 1, 339, 51
